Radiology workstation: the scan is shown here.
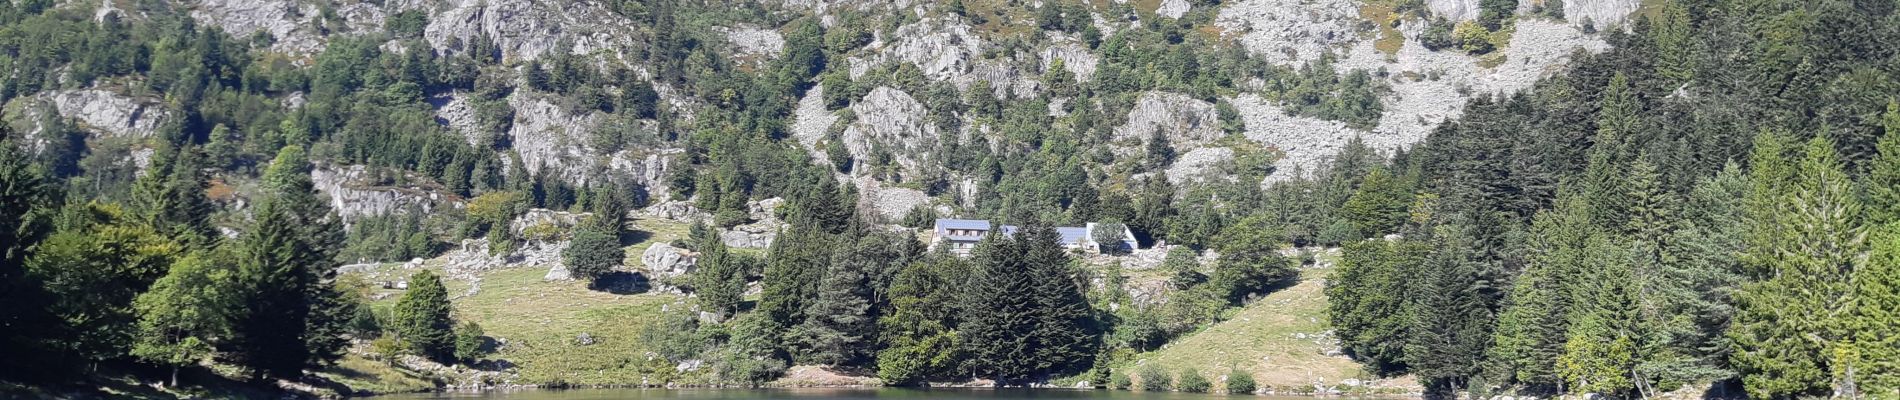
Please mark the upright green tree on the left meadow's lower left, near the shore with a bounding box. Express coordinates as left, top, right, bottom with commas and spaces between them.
395, 269, 456, 362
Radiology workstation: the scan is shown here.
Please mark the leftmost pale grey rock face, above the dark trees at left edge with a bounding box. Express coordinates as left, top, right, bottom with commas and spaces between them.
40, 89, 171, 138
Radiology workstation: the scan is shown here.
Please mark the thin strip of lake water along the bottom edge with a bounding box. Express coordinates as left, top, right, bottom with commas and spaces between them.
376, 389, 1360, 400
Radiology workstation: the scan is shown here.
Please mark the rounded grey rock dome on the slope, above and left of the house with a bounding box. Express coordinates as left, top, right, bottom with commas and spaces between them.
842, 87, 937, 179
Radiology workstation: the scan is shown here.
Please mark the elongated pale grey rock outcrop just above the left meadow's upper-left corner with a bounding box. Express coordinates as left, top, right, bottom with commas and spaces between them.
310, 165, 464, 224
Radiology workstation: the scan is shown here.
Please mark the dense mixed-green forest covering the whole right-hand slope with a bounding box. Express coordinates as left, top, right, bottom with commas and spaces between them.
1326, 2, 1900, 398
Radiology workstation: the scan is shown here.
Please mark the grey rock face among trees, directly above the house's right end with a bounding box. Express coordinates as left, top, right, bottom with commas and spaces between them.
1115, 91, 1222, 152
